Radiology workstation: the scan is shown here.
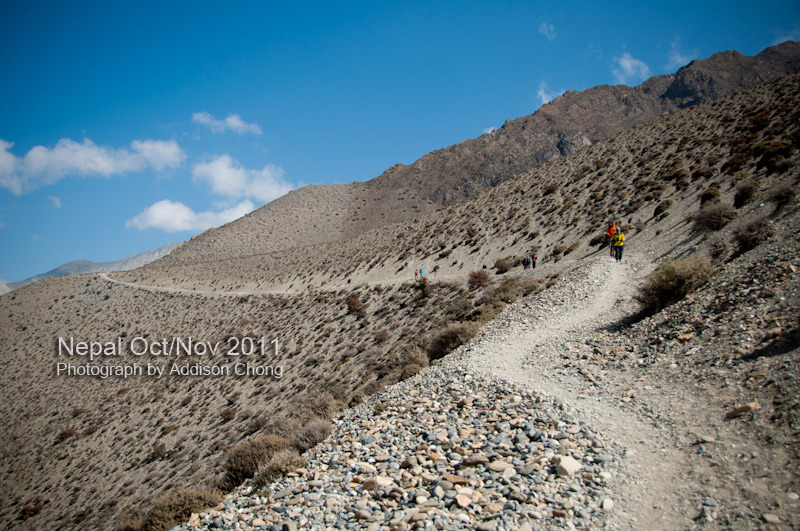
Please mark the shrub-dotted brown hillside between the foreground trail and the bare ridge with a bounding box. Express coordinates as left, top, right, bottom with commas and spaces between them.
0, 68, 800, 529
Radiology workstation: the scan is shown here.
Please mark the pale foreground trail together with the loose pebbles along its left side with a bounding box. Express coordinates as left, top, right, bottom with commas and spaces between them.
177, 253, 689, 531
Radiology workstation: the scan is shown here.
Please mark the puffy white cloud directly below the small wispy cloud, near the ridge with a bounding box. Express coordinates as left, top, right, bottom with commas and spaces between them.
192, 155, 293, 202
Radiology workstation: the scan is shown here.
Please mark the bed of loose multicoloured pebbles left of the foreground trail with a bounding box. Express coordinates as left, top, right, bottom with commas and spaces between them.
173, 363, 618, 531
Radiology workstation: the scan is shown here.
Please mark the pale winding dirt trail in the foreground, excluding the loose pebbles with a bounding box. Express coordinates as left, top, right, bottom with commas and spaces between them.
467, 253, 692, 529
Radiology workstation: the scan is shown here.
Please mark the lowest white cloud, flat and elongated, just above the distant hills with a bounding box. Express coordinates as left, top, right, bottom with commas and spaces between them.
125, 199, 255, 232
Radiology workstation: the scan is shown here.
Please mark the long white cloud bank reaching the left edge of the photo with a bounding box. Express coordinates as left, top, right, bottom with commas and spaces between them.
0, 138, 186, 195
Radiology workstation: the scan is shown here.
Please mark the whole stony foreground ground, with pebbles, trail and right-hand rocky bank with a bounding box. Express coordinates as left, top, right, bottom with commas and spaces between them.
177, 225, 800, 530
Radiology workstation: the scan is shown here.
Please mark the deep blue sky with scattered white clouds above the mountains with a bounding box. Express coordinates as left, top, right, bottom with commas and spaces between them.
0, 0, 800, 281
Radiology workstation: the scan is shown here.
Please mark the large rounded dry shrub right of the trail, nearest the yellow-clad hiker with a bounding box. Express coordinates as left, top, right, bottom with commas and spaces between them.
635, 257, 714, 314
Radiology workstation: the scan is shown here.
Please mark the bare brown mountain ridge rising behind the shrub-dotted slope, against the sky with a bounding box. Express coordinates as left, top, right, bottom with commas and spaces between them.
161, 42, 800, 264
